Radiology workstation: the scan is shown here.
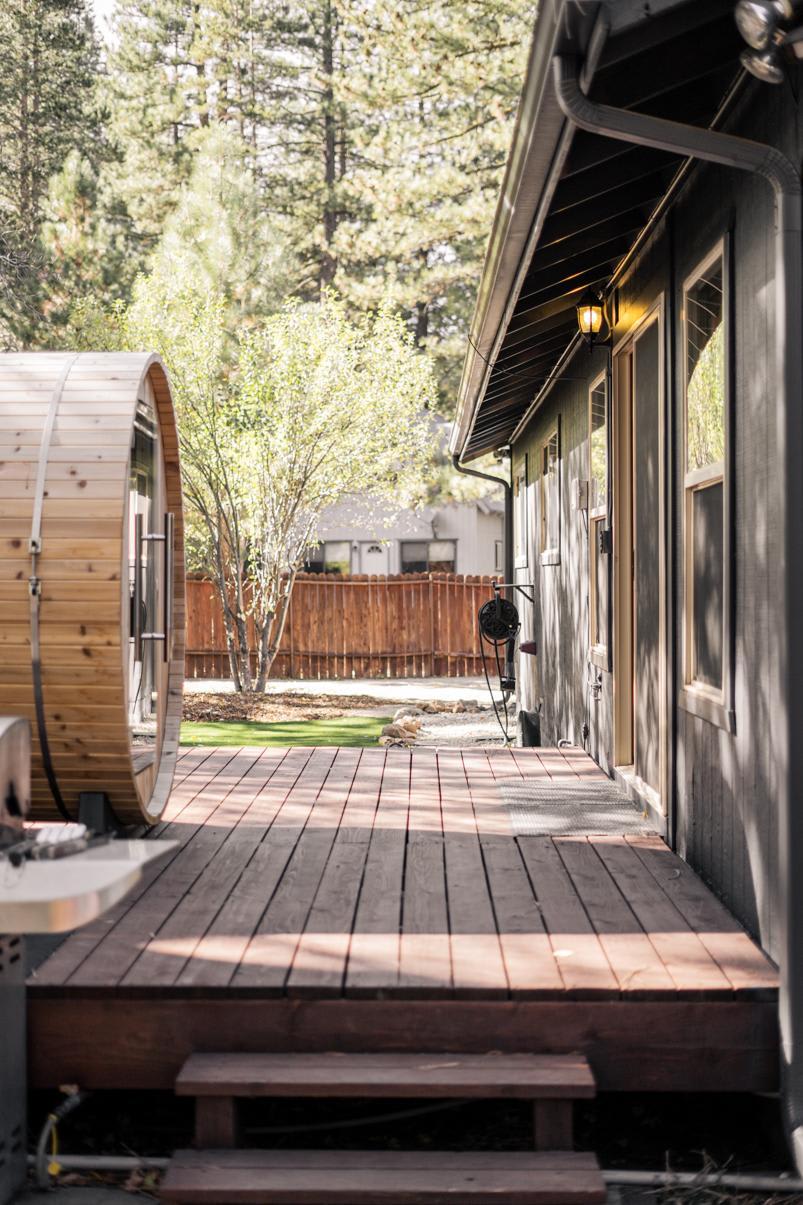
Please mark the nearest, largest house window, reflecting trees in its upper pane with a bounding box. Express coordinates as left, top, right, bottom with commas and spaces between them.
682, 246, 732, 723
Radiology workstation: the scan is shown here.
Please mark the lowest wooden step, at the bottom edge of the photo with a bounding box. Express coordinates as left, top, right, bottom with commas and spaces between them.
160, 1151, 605, 1205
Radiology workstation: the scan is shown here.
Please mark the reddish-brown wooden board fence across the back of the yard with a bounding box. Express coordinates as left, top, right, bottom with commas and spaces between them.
186, 574, 492, 678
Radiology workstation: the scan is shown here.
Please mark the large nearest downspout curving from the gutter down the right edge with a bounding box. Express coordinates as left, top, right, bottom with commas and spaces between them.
552, 55, 803, 1171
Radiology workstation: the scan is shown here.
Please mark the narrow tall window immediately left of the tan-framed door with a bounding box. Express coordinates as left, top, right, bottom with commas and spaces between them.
588, 374, 608, 669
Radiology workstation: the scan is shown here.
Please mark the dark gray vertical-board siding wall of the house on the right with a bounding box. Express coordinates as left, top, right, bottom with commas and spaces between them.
512, 75, 803, 954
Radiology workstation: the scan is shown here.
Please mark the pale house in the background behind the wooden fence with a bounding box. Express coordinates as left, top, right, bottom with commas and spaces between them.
305, 498, 504, 575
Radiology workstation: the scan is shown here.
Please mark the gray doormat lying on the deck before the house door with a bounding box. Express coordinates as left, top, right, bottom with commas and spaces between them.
497, 778, 655, 836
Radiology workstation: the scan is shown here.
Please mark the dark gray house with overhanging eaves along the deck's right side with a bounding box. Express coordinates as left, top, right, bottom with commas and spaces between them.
451, 0, 803, 1165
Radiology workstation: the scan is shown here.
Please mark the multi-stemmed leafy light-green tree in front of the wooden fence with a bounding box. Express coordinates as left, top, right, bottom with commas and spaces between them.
74, 284, 434, 690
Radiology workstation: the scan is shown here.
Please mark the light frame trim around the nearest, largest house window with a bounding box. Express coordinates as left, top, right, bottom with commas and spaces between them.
679, 237, 735, 733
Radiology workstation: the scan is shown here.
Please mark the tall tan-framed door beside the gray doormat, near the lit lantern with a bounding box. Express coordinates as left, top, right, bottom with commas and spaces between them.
614, 307, 667, 812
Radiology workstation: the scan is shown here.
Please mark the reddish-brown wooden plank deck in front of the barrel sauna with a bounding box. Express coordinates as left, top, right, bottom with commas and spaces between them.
29, 748, 778, 1091
